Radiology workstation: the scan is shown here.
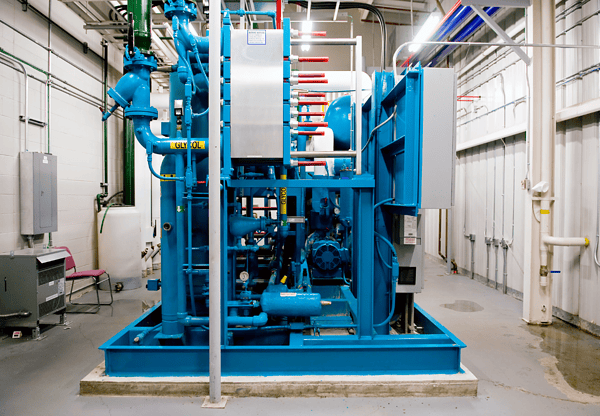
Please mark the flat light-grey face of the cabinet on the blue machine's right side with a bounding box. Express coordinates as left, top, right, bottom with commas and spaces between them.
421, 68, 456, 208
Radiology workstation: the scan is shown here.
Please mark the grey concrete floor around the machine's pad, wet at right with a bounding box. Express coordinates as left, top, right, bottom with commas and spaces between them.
0, 259, 600, 416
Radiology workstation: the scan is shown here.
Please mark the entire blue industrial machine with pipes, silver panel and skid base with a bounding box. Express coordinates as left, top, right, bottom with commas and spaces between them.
101, 0, 464, 376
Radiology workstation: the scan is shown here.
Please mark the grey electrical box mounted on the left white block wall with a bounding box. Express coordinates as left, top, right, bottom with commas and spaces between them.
19, 152, 58, 235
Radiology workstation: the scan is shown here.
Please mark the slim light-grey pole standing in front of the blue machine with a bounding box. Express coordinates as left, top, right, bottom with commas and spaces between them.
208, 0, 221, 404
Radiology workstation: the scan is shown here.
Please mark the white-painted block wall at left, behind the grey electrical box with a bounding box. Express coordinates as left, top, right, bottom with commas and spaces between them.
0, 0, 122, 270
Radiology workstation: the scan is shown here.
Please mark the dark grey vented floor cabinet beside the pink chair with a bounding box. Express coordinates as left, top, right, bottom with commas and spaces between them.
0, 248, 69, 328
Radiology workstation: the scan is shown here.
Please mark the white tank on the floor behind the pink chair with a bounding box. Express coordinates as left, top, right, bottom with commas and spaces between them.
98, 207, 142, 290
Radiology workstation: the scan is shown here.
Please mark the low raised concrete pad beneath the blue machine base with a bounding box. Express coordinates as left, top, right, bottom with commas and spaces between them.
79, 362, 478, 397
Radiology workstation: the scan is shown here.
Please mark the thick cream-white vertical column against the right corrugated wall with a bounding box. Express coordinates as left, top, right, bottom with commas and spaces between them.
523, 0, 556, 325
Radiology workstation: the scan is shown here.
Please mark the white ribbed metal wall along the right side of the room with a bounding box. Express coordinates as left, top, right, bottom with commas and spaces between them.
425, 0, 600, 329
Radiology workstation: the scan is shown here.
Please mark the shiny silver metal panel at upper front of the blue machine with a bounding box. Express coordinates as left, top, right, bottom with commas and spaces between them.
231, 30, 283, 159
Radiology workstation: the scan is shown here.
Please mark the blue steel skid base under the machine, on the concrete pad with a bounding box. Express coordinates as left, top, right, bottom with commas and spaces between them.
100, 303, 465, 377
